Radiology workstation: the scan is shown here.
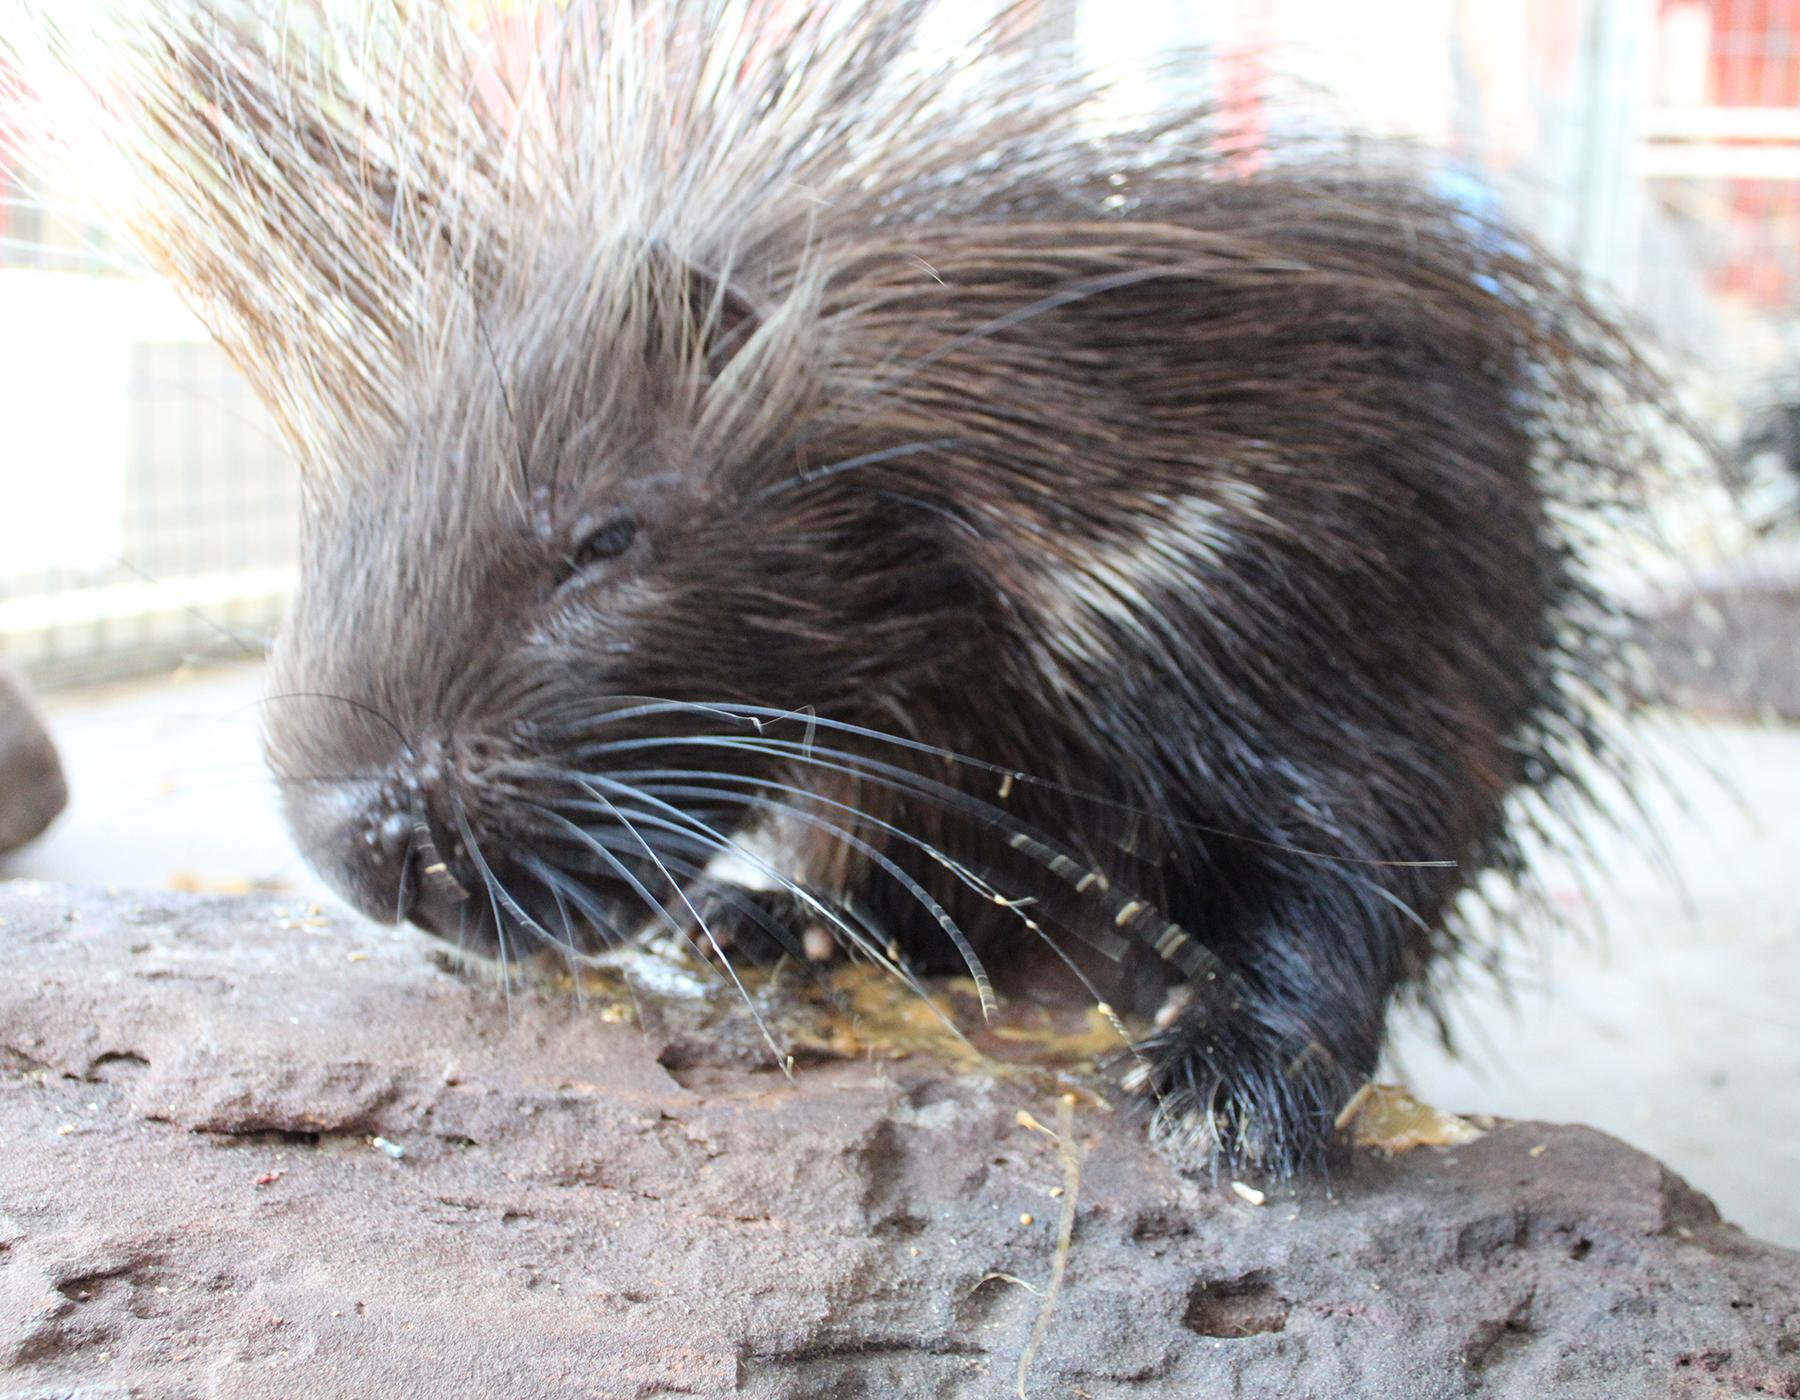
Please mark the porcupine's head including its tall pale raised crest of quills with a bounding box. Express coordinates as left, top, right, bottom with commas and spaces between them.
3, 0, 1080, 956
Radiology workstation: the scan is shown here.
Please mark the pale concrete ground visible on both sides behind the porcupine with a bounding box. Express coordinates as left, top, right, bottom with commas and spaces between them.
0, 666, 1800, 1247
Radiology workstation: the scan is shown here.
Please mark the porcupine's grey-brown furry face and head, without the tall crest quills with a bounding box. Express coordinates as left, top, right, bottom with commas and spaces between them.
266, 239, 1000, 952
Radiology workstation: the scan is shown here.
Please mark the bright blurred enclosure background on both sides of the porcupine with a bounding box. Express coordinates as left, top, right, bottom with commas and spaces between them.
0, 0, 1800, 1245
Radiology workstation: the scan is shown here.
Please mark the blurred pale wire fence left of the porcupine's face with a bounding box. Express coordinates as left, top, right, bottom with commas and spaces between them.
0, 68, 299, 686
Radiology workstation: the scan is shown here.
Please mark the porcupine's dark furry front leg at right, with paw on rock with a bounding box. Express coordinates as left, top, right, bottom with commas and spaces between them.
1108, 478, 1533, 1171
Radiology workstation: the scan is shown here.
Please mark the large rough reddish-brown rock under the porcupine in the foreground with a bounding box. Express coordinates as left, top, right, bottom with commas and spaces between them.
0, 884, 1800, 1400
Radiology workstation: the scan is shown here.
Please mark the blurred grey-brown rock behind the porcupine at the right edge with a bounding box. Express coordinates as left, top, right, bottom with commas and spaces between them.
1651, 540, 1800, 720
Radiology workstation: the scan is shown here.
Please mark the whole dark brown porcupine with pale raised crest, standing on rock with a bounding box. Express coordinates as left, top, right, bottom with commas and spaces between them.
3, 0, 1660, 1171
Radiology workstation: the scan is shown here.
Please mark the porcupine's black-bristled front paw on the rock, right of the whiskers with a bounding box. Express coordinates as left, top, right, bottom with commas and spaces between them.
1123, 995, 1373, 1179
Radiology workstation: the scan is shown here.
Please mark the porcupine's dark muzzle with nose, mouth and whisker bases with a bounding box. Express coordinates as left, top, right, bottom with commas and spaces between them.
338, 698, 785, 959
